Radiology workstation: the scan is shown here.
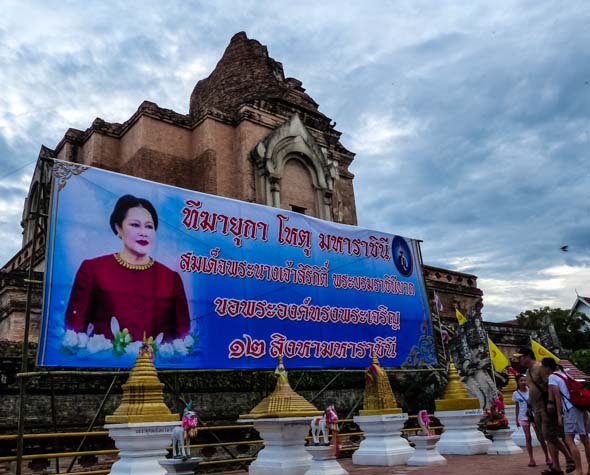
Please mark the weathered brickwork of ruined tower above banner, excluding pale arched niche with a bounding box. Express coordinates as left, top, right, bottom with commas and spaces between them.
47, 33, 356, 224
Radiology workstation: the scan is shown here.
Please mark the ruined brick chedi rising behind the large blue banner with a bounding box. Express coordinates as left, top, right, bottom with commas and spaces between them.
0, 33, 357, 341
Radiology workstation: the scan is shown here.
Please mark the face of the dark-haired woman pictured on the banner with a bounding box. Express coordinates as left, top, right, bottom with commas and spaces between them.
115, 206, 156, 256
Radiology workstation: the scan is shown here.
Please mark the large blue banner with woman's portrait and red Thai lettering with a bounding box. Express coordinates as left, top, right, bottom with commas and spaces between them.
38, 161, 436, 368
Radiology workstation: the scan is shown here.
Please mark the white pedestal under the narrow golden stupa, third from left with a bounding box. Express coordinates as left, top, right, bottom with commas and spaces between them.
352, 414, 414, 466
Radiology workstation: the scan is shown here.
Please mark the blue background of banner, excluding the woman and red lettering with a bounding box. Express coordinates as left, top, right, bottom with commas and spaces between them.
38, 162, 436, 369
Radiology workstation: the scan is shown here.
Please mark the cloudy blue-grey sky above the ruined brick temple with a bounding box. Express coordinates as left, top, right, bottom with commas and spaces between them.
0, 0, 590, 321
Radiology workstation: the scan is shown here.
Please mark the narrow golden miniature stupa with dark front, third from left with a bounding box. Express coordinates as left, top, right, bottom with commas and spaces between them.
359, 351, 402, 416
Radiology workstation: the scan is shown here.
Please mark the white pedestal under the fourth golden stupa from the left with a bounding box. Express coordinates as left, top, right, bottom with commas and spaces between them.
434, 409, 492, 455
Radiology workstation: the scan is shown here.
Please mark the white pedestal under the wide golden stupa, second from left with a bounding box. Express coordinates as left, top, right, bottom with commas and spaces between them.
240, 417, 313, 475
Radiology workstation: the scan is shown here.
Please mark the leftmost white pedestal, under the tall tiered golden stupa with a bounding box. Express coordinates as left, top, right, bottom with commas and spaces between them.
104, 421, 180, 475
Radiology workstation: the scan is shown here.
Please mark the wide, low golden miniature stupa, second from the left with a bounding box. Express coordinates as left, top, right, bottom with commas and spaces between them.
240, 356, 323, 419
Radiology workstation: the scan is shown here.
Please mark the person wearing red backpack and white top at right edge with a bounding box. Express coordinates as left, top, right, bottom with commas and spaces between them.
541, 358, 590, 475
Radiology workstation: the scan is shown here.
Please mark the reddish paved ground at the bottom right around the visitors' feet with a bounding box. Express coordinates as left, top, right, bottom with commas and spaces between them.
218, 450, 588, 475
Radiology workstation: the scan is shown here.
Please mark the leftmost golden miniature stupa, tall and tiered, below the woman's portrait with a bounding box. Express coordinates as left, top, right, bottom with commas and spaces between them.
105, 344, 180, 424
